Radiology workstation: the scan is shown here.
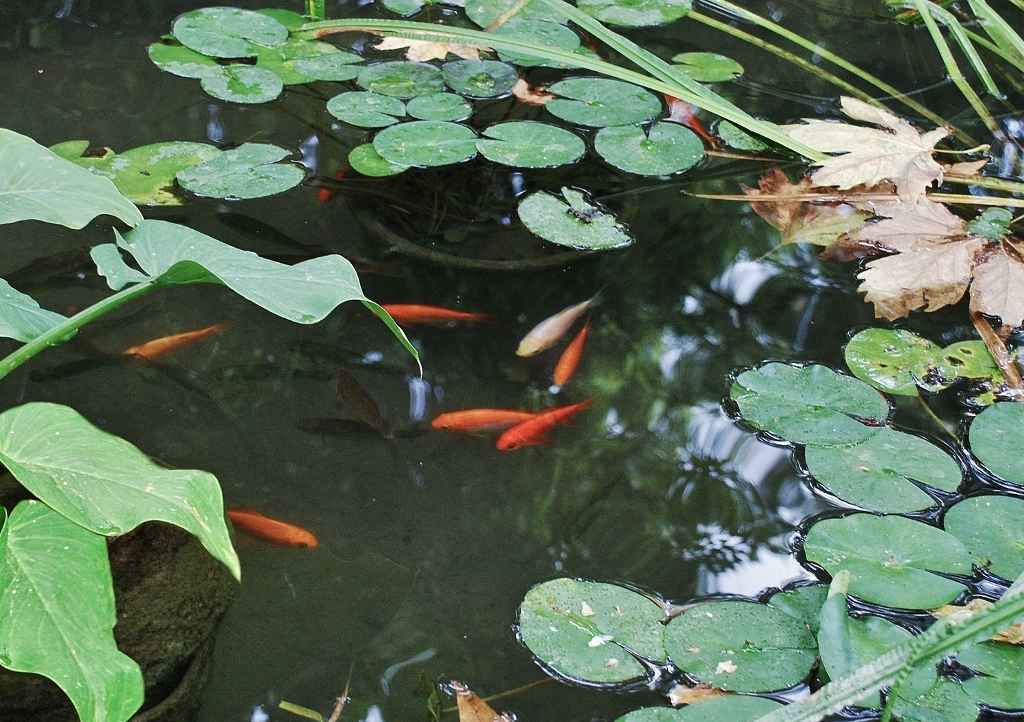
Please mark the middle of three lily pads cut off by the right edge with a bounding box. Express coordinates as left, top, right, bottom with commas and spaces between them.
942, 496, 1024, 580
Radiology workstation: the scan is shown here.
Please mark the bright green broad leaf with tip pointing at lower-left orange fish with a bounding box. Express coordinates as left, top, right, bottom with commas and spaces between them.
0, 405, 241, 578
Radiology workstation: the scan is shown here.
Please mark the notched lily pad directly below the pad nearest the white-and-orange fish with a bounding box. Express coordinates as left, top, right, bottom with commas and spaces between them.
804, 427, 962, 513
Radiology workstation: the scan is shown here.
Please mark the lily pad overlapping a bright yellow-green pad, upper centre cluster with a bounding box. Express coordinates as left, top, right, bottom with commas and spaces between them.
374, 121, 476, 167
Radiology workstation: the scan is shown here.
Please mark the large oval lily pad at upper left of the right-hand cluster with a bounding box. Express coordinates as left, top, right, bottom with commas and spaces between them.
729, 364, 889, 447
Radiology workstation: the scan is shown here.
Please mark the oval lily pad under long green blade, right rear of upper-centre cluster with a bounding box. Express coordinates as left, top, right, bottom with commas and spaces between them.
545, 78, 659, 126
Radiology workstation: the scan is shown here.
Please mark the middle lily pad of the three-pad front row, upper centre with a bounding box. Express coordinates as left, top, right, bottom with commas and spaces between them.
476, 121, 587, 168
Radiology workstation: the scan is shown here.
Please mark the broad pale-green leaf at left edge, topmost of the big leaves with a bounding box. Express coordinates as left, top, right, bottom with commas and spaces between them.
0, 128, 142, 228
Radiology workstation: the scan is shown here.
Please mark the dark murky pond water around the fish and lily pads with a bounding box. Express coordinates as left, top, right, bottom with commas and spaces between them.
0, 0, 1007, 722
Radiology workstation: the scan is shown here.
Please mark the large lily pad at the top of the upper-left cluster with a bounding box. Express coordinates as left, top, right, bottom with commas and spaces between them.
171, 7, 288, 57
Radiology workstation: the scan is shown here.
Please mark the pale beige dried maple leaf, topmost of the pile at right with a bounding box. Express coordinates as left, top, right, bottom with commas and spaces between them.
782, 97, 949, 205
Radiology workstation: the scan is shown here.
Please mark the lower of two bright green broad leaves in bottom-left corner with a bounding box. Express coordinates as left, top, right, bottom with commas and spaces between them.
0, 497, 144, 722
